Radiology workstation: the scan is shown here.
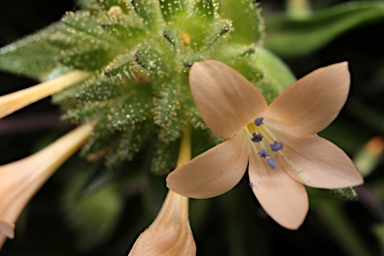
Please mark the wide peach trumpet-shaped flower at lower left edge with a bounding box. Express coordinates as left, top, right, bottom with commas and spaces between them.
0, 124, 92, 248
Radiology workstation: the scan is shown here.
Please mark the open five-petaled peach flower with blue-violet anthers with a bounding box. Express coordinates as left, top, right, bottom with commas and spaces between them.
167, 60, 363, 229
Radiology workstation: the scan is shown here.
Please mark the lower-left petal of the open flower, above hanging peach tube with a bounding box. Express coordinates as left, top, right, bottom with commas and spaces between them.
167, 133, 249, 198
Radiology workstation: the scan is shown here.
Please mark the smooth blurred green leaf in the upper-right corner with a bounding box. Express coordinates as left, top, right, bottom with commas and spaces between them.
264, 2, 384, 57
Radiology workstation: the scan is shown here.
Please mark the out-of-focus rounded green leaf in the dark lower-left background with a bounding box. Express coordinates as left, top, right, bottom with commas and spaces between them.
62, 169, 123, 251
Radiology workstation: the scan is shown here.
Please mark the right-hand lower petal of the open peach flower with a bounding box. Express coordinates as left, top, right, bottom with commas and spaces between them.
274, 131, 364, 189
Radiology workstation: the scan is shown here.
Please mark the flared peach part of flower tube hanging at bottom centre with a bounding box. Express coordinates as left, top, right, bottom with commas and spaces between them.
128, 190, 196, 256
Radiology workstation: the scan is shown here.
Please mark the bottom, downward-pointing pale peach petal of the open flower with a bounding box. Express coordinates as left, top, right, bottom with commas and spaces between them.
249, 152, 308, 229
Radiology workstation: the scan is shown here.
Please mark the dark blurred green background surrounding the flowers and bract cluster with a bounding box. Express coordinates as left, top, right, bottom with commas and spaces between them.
0, 0, 384, 256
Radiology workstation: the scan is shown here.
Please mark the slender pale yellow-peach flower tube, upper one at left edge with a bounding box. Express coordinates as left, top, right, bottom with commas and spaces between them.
0, 71, 90, 118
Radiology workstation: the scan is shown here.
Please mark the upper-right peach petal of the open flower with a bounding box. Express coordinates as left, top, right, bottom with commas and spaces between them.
265, 62, 350, 136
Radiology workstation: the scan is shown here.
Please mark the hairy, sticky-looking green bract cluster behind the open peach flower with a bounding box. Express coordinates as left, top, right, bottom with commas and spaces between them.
0, 0, 291, 173
